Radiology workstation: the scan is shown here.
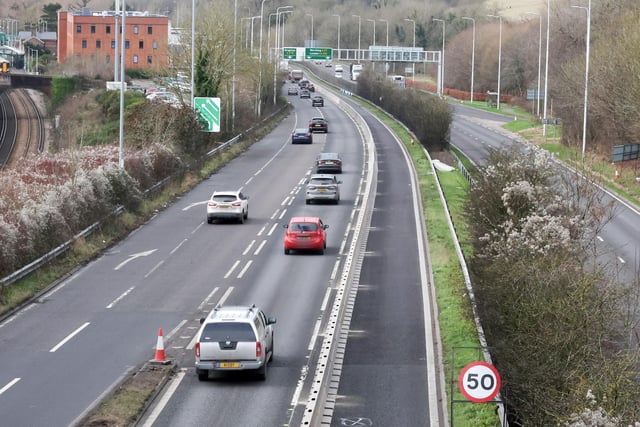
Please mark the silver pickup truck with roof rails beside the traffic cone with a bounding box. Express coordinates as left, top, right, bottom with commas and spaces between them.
195, 305, 276, 381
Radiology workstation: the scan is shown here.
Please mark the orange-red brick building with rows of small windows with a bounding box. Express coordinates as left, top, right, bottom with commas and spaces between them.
58, 8, 169, 69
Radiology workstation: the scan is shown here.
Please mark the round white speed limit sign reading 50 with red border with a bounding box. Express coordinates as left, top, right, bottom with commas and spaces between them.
458, 362, 501, 403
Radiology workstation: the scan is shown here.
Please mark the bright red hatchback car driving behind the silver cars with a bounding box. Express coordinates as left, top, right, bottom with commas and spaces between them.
284, 217, 329, 255
